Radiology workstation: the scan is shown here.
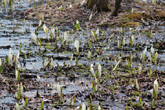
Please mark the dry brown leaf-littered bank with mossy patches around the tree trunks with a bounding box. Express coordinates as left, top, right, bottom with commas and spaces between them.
18, 0, 165, 28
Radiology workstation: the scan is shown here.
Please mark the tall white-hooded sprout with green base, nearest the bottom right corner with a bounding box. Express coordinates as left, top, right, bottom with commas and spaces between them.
150, 79, 159, 99
